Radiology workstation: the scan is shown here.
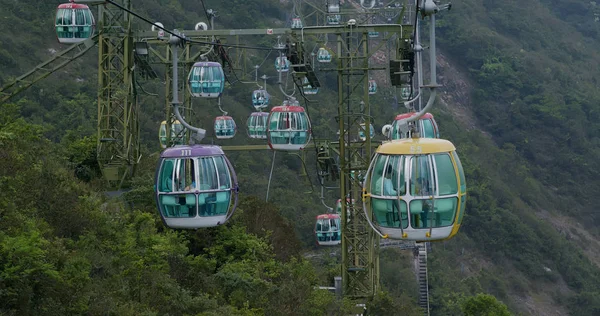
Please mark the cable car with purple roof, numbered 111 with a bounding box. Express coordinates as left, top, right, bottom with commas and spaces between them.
154, 145, 238, 229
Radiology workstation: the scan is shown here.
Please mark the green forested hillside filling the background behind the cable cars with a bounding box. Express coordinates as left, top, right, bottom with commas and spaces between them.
0, 0, 600, 315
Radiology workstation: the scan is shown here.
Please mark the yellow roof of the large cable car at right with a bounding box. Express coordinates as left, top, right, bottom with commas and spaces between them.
377, 138, 456, 155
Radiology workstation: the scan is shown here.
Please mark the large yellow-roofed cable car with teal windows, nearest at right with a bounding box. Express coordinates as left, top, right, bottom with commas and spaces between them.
363, 138, 466, 242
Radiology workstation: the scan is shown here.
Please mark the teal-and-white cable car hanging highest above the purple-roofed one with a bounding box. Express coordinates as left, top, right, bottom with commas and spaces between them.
188, 61, 225, 98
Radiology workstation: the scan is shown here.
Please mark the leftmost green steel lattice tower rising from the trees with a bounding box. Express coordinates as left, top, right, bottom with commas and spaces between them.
97, 0, 140, 188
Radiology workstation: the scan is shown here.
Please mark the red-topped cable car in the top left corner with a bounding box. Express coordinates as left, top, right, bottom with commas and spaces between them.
54, 0, 96, 44
